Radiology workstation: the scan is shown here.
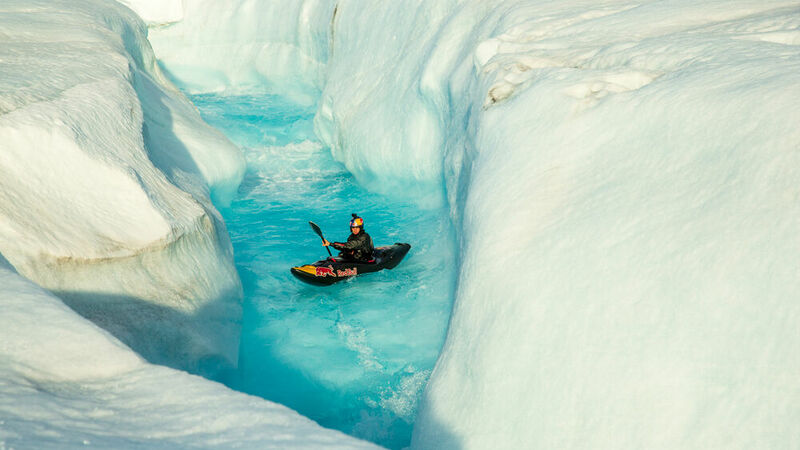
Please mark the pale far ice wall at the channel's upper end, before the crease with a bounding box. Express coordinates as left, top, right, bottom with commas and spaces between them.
141, 0, 336, 103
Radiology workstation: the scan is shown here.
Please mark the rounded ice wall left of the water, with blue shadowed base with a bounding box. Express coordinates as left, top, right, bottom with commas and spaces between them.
0, 0, 244, 371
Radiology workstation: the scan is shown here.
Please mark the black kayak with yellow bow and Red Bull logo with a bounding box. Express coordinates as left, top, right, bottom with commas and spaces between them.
291, 242, 411, 286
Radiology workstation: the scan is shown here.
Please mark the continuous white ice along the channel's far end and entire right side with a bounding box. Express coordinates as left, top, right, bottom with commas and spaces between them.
139, 0, 800, 448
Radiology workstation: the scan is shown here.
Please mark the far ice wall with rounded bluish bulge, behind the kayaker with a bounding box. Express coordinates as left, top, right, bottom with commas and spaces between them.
140, 0, 457, 206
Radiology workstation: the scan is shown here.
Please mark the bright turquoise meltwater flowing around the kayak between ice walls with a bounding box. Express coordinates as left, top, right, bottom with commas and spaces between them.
192, 94, 455, 448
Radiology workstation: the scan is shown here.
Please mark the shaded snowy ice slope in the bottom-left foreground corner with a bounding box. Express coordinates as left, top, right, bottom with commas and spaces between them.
0, 256, 375, 449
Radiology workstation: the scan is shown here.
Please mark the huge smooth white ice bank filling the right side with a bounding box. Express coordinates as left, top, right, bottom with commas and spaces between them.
414, 2, 800, 448
